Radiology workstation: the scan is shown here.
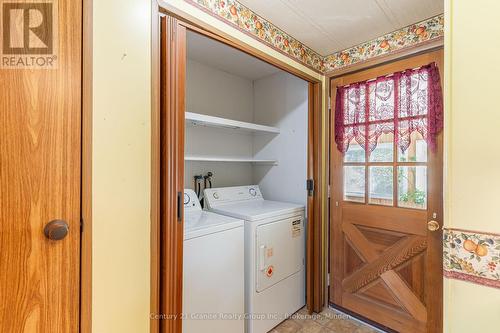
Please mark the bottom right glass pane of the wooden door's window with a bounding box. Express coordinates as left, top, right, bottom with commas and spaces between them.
398, 166, 427, 209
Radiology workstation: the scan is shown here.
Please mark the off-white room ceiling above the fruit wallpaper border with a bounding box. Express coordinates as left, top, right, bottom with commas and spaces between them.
238, 0, 444, 55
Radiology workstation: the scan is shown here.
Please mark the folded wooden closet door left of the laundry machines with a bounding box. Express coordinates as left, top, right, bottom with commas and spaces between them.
159, 15, 186, 333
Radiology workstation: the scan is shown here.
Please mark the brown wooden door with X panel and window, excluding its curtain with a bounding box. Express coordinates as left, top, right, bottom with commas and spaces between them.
330, 51, 443, 333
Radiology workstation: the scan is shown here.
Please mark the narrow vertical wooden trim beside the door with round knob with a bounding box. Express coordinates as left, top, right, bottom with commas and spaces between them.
80, 0, 93, 333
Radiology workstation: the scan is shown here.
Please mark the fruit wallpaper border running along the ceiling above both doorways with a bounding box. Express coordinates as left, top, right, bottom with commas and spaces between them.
184, 0, 444, 74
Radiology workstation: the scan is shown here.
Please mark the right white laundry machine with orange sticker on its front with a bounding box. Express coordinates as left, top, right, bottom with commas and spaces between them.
204, 185, 305, 333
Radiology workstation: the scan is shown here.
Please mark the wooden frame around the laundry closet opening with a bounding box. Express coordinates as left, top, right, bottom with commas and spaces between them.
150, 0, 326, 333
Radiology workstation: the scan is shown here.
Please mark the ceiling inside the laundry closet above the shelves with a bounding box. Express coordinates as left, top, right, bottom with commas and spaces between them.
187, 31, 280, 81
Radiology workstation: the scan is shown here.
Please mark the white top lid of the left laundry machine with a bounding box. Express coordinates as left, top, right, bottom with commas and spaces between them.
184, 210, 243, 240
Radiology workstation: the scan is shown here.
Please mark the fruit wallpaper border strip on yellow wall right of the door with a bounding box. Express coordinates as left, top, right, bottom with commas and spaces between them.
443, 229, 500, 288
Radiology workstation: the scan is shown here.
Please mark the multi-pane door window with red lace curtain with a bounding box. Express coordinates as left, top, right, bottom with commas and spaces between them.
335, 64, 442, 210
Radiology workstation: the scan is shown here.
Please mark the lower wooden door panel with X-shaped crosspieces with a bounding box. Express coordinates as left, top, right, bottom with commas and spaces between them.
340, 203, 427, 332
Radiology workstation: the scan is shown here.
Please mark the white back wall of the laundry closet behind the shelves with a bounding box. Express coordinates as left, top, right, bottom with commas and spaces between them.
184, 59, 253, 189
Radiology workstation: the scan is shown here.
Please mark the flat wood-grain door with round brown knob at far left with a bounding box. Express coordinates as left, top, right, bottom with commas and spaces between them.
0, 0, 82, 333
